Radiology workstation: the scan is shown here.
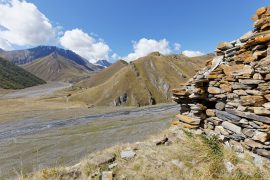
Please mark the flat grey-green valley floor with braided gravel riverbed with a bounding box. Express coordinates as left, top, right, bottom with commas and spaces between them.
0, 91, 179, 178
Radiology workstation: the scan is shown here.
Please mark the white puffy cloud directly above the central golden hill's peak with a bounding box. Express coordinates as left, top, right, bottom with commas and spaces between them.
123, 38, 172, 61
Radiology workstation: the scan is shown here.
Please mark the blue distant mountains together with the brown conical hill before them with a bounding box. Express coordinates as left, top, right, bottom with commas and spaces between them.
0, 46, 111, 83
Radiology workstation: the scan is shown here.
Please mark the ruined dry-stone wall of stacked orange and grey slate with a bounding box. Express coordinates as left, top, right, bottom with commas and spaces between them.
173, 7, 270, 158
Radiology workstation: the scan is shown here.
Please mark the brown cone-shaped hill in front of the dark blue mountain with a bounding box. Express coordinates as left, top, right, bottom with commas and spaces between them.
21, 52, 93, 83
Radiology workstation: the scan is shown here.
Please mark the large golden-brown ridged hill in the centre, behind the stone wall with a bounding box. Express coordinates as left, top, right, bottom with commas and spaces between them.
70, 52, 213, 106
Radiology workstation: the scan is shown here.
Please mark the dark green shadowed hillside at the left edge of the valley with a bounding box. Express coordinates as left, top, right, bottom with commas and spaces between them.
0, 58, 46, 89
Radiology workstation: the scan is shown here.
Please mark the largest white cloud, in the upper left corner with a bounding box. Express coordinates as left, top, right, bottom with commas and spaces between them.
0, 0, 56, 48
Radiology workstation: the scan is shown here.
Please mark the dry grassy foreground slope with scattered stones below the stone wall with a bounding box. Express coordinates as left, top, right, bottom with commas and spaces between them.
23, 127, 270, 180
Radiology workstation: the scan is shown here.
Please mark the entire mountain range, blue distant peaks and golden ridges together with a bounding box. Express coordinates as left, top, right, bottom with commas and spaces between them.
0, 46, 213, 106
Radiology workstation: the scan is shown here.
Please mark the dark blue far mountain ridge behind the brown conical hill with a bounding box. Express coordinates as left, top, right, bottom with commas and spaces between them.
0, 46, 100, 71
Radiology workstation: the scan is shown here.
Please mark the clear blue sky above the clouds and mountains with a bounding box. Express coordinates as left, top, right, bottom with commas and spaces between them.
0, 0, 270, 62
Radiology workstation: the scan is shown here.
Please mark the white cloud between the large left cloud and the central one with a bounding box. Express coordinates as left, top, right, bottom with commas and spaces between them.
60, 29, 110, 63
